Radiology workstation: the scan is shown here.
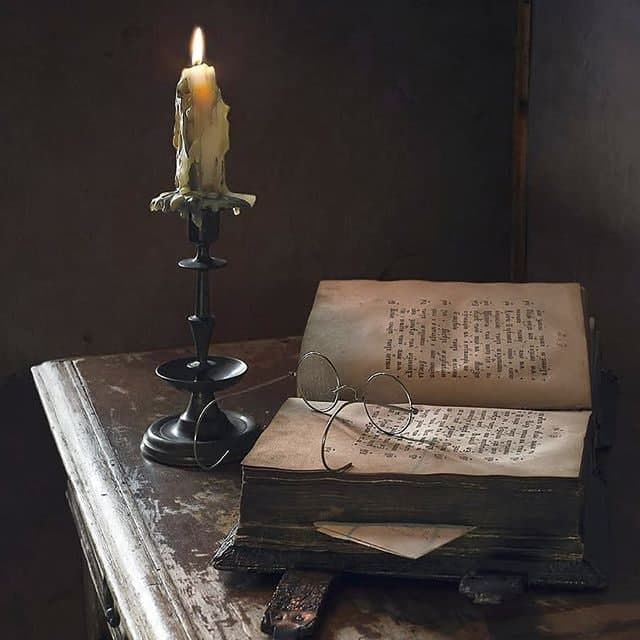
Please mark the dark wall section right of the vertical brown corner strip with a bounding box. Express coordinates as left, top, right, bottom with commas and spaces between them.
528, 0, 640, 599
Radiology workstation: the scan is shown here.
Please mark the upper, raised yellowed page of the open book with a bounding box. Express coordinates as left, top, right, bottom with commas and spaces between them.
301, 280, 591, 409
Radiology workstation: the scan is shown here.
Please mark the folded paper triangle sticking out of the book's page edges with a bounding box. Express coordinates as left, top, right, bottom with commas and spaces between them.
313, 521, 475, 560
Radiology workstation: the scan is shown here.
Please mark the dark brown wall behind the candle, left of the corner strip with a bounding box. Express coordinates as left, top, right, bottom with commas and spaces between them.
0, 0, 515, 638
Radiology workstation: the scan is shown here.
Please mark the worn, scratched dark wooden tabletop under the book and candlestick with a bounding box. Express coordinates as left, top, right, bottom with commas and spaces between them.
34, 338, 640, 640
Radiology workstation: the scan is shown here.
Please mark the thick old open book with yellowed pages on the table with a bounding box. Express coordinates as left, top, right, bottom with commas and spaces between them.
215, 281, 604, 582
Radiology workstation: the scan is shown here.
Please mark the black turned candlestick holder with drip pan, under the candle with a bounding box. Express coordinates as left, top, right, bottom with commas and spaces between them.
140, 192, 258, 467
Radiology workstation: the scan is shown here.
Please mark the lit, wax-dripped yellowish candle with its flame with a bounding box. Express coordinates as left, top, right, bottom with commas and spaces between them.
173, 27, 229, 194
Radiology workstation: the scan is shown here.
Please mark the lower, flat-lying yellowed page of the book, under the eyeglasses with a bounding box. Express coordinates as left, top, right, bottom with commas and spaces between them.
243, 398, 591, 478
